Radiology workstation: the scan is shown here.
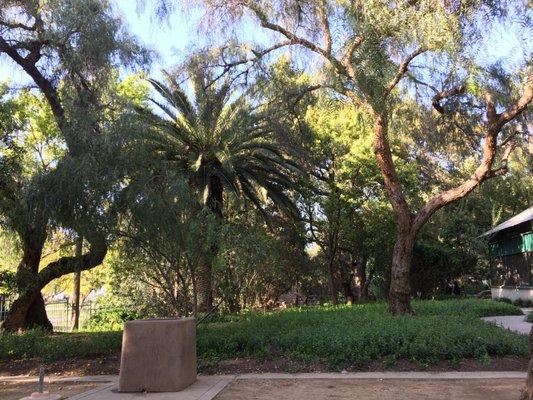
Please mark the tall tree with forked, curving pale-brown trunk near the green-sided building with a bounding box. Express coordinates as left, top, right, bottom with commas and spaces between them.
194, 0, 533, 314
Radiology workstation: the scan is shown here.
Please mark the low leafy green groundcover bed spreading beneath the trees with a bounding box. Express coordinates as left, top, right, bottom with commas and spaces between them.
0, 299, 528, 368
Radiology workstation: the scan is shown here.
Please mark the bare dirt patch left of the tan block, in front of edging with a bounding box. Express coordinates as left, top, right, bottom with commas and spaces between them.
0, 382, 97, 400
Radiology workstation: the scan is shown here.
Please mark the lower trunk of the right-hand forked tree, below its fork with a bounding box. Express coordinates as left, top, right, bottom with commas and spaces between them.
389, 226, 415, 315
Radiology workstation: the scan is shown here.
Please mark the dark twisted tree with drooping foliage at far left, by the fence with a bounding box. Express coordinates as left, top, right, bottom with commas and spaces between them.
0, 0, 147, 330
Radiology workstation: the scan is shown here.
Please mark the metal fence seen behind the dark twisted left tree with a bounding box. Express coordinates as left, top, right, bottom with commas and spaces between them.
0, 295, 103, 332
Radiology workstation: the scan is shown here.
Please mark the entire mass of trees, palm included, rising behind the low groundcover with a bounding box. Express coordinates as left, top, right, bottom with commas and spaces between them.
0, 0, 533, 330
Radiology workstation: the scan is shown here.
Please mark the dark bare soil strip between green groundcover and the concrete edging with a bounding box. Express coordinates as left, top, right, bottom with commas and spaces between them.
0, 354, 528, 377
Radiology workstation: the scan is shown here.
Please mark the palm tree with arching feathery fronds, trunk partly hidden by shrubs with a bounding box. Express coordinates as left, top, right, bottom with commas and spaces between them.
142, 64, 296, 312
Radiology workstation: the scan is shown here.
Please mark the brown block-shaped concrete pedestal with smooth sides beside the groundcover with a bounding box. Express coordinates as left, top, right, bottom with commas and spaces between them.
119, 318, 196, 392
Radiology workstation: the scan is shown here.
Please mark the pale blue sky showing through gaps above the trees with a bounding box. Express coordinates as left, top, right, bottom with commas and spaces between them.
0, 0, 533, 84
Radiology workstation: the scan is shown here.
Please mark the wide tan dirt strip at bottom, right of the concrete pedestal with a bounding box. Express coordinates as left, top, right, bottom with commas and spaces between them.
215, 379, 524, 400
